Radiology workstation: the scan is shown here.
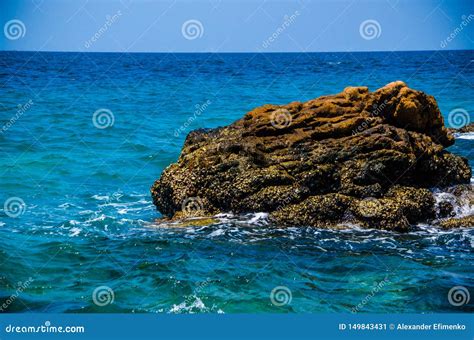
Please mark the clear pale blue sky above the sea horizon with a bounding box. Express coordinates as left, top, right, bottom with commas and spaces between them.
0, 0, 474, 52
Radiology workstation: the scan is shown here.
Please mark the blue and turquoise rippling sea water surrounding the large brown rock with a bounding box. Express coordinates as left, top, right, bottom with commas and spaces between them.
0, 51, 474, 313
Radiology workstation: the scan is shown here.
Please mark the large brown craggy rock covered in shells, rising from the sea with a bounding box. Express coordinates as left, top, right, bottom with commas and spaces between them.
151, 81, 471, 231
